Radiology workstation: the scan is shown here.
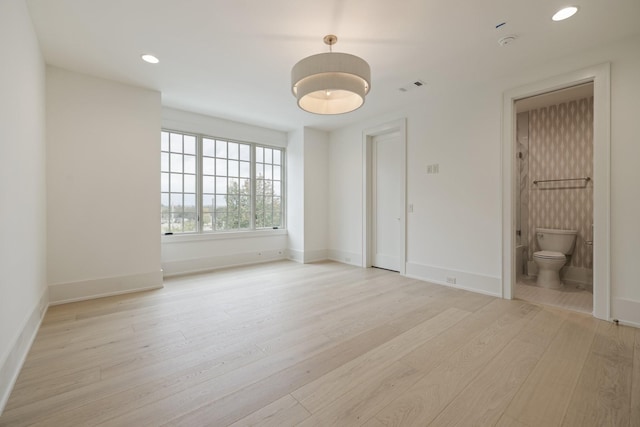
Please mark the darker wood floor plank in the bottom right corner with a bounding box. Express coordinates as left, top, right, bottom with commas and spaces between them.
562, 322, 639, 427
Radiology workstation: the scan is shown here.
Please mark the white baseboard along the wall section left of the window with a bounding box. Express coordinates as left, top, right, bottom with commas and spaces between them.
49, 270, 163, 305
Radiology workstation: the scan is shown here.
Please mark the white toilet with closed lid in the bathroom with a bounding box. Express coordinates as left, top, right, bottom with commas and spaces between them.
533, 228, 578, 289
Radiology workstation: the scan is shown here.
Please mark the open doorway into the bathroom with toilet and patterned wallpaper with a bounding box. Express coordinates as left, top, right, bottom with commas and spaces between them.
513, 82, 593, 314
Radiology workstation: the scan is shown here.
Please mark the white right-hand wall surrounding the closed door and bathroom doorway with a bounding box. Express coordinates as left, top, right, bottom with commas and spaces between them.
329, 37, 640, 324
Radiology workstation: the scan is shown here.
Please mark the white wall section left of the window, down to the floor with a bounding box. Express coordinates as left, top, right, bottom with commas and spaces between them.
46, 67, 162, 302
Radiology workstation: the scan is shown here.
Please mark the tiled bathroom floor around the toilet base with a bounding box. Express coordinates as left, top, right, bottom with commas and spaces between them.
515, 276, 593, 314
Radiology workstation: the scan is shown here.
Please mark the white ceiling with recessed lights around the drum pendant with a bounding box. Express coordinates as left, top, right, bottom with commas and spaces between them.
23, 0, 640, 130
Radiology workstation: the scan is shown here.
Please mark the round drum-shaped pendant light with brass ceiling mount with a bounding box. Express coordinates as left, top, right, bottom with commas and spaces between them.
291, 35, 371, 114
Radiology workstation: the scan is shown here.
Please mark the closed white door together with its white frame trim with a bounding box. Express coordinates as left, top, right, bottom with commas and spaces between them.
362, 119, 407, 275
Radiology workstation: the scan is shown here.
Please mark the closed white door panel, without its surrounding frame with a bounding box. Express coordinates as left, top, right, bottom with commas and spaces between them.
371, 132, 404, 271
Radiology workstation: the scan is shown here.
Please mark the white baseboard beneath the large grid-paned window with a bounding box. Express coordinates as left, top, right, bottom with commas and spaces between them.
162, 249, 288, 277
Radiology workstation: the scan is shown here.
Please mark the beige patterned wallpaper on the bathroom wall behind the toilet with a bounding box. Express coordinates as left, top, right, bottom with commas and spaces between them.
523, 97, 593, 268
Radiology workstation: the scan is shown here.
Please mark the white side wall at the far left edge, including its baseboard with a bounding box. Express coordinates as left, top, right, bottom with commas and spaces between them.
0, 0, 47, 413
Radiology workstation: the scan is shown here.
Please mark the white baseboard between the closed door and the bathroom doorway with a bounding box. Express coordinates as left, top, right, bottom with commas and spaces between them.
406, 263, 502, 298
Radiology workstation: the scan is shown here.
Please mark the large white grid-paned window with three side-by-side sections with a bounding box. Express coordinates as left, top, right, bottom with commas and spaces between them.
160, 131, 284, 234
